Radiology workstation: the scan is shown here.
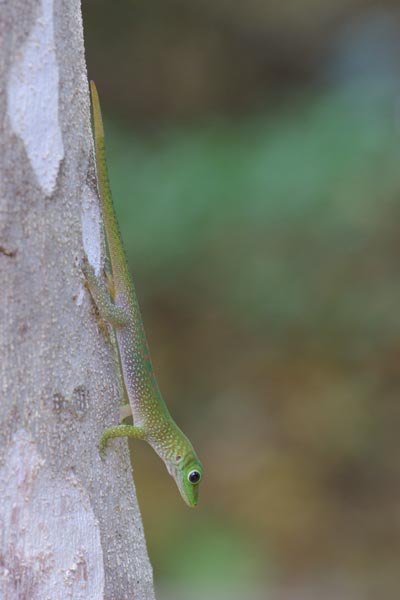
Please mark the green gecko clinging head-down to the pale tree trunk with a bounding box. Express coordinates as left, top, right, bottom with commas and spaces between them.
82, 81, 203, 506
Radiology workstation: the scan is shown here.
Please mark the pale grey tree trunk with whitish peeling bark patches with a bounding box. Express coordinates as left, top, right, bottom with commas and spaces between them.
0, 0, 154, 600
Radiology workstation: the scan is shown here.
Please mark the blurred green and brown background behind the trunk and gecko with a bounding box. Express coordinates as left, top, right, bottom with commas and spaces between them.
83, 0, 400, 600
